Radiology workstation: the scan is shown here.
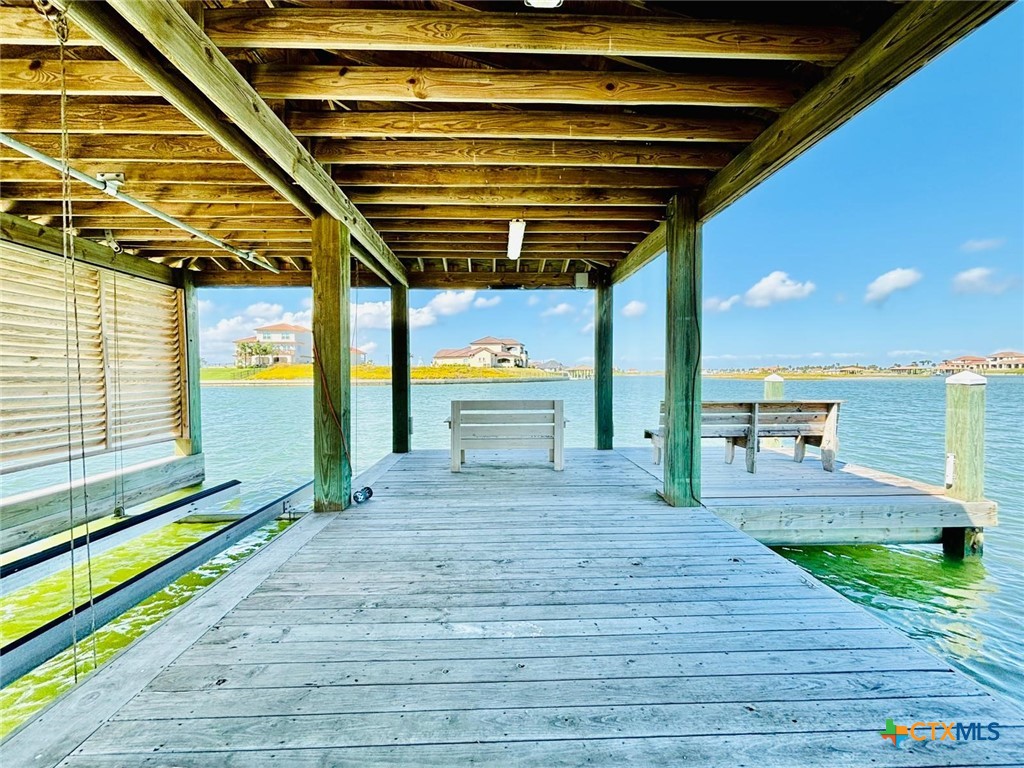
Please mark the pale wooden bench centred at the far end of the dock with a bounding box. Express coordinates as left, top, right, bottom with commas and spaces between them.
444, 400, 565, 472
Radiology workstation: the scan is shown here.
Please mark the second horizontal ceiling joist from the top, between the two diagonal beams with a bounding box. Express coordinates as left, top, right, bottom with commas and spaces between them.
253, 65, 802, 110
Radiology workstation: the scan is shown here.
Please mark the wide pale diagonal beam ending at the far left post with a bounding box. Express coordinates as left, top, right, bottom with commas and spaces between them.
101, 0, 407, 285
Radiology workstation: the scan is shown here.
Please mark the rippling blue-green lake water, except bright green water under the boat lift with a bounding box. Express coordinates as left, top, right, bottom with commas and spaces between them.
4, 376, 1024, 701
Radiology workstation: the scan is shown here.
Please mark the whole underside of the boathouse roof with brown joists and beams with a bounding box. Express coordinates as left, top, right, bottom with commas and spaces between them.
0, 0, 1006, 288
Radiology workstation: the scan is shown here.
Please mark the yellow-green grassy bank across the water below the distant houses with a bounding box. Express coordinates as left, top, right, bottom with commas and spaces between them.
200, 362, 565, 383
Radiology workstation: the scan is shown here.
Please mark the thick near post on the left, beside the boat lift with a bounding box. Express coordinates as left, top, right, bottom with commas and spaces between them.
311, 213, 352, 512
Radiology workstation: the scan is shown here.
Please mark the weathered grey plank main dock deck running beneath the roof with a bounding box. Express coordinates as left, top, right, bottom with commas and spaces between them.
6, 450, 1024, 768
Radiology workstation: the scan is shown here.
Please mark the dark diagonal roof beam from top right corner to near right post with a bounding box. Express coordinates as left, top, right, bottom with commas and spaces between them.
700, 0, 1010, 219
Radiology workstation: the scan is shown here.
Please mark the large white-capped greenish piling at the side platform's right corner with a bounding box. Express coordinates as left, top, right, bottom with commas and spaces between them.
942, 371, 986, 560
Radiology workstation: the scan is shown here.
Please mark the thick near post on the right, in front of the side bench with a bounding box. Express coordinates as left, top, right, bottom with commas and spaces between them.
664, 194, 701, 507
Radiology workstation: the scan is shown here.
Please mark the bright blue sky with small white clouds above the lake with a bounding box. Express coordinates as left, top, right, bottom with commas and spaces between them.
200, 4, 1024, 369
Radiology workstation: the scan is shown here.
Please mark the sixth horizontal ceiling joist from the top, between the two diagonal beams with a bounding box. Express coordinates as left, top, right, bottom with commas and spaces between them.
348, 184, 668, 206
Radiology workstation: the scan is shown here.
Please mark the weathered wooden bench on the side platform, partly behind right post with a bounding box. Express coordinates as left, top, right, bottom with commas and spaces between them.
644, 400, 843, 472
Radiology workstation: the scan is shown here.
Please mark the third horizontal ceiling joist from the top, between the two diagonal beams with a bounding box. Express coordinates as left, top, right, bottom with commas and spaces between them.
288, 110, 764, 144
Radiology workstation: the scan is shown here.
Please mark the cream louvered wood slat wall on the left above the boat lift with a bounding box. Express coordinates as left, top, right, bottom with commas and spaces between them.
0, 243, 182, 472
